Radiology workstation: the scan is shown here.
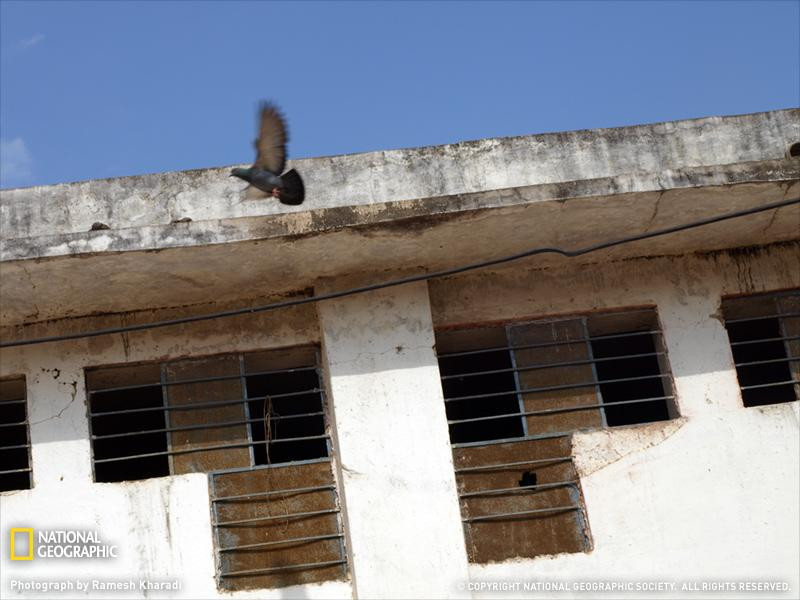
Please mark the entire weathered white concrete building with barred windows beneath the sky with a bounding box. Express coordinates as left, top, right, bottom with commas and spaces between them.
0, 110, 800, 598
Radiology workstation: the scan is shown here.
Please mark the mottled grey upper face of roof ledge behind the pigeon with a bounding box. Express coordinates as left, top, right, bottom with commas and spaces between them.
0, 109, 800, 241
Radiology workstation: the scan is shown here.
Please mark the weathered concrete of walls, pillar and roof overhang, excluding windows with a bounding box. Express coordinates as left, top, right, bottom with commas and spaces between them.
0, 110, 800, 598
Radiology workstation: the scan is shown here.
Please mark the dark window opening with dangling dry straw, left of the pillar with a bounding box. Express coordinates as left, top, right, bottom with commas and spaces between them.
247, 369, 328, 465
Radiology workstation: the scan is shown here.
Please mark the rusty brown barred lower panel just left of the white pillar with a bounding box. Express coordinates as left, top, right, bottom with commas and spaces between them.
210, 459, 347, 590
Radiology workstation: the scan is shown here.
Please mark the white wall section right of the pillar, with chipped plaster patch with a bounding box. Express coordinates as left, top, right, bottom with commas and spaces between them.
431, 246, 800, 598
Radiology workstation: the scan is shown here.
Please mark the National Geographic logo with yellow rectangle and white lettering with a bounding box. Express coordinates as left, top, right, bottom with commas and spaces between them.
8, 527, 119, 560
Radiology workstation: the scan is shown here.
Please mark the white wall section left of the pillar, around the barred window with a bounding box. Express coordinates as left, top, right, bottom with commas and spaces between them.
0, 308, 352, 598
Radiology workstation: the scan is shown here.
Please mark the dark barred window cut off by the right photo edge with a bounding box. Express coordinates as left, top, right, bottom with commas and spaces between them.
722, 290, 800, 406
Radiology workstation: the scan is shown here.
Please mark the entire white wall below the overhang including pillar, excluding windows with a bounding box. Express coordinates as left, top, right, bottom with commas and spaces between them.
0, 245, 800, 598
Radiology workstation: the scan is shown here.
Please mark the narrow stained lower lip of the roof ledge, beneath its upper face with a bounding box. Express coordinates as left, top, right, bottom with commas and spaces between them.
0, 159, 800, 261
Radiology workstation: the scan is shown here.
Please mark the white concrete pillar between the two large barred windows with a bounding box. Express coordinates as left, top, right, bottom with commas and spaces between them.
319, 283, 468, 598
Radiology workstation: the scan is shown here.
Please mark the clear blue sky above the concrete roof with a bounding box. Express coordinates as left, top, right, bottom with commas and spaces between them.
0, 0, 800, 187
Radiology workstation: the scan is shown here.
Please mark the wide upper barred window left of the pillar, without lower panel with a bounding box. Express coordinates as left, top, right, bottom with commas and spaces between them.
86, 347, 329, 482
